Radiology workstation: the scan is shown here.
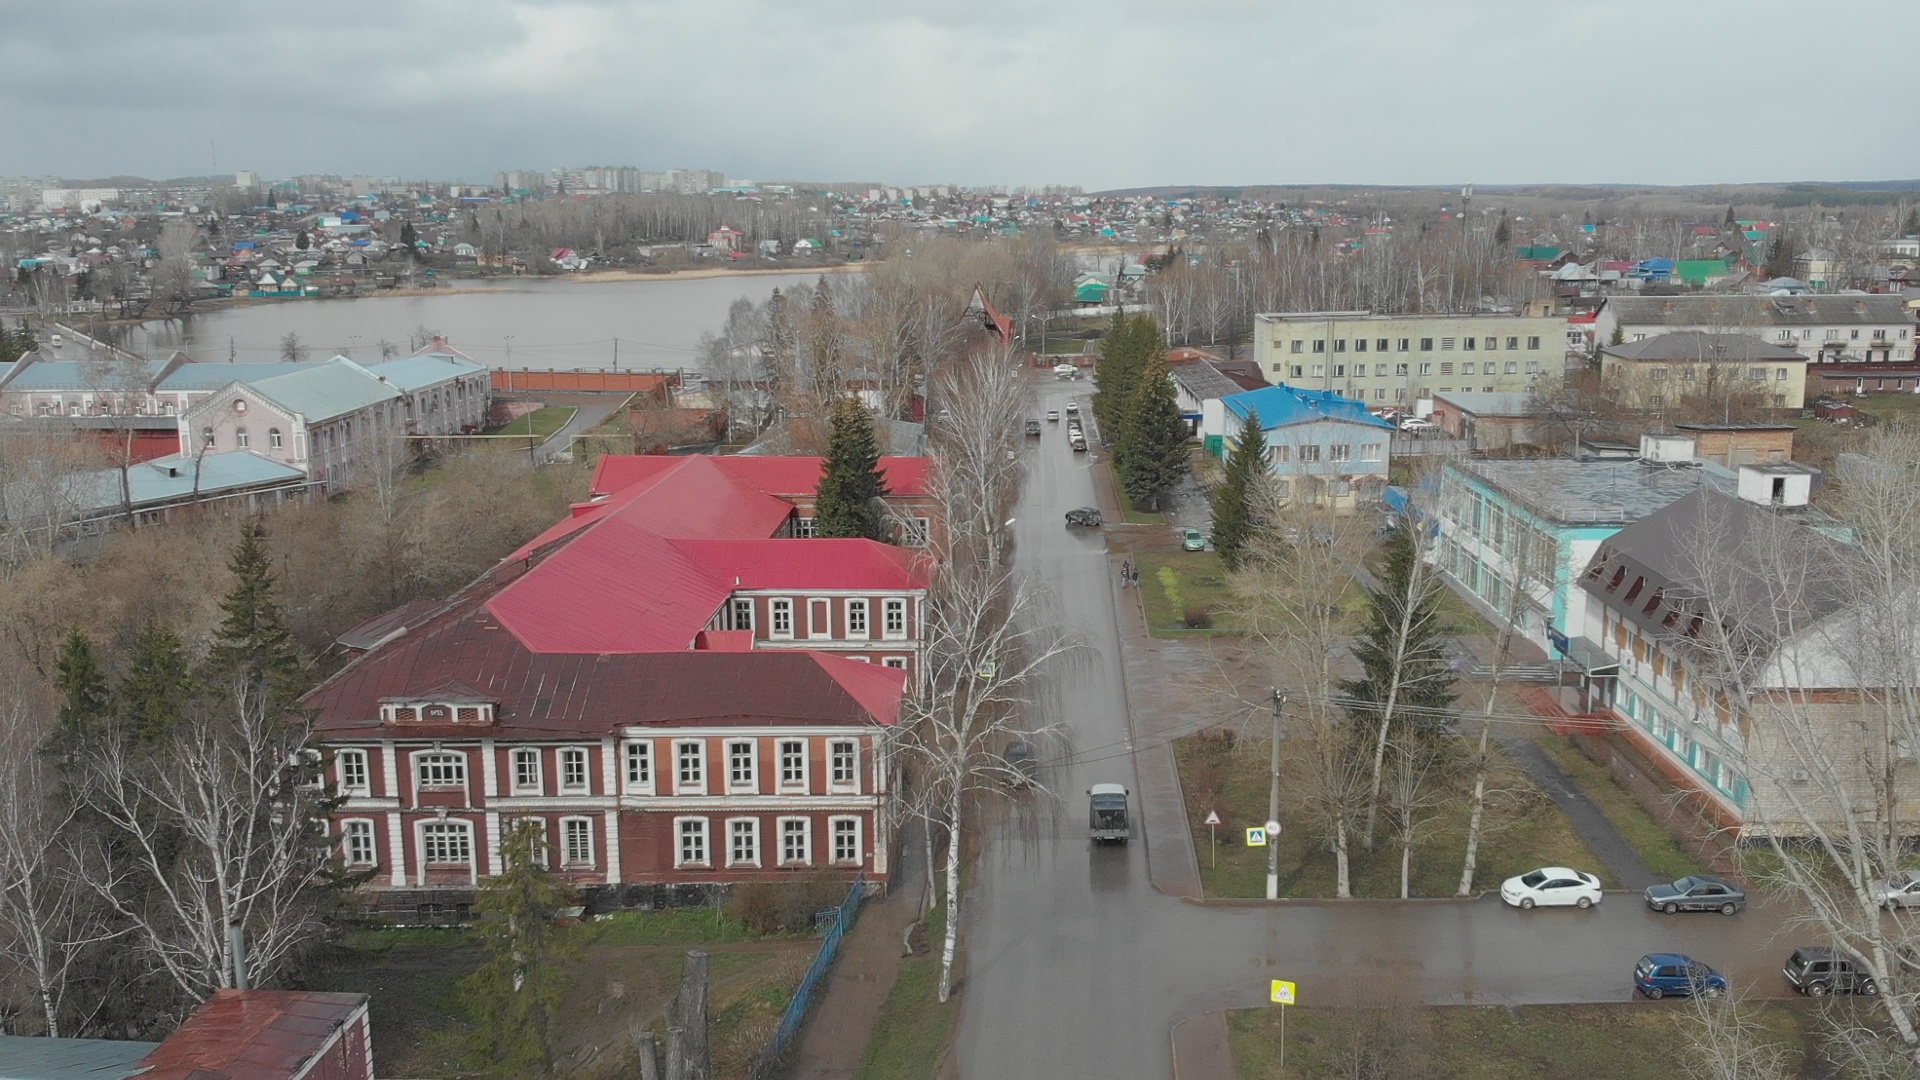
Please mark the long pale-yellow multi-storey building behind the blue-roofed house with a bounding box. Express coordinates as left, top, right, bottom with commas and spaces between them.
1254, 311, 1567, 407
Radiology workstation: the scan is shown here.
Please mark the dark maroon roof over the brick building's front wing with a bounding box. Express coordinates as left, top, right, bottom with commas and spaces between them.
305, 600, 906, 738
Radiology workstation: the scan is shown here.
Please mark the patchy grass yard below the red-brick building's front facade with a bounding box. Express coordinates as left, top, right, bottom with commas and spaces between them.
301, 907, 818, 1080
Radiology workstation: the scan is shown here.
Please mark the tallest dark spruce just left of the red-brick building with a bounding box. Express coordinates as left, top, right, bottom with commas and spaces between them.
205, 519, 307, 715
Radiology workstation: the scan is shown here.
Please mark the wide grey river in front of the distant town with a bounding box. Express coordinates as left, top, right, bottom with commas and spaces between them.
132, 273, 833, 371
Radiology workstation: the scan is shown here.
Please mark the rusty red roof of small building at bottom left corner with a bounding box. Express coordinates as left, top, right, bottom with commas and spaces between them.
140, 990, 367, 1080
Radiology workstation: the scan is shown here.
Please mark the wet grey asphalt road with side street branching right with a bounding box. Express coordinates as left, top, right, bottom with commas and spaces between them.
956, 380, 1801, 1080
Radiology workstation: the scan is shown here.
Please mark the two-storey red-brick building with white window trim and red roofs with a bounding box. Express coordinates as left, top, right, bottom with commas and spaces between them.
305, 449, 929, 915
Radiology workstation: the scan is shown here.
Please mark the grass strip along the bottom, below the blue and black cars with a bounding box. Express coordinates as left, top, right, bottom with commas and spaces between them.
1227, 988, 1816, 1080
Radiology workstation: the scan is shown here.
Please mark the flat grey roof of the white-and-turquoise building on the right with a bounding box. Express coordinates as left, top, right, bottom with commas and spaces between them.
1452, 449, 1740, 525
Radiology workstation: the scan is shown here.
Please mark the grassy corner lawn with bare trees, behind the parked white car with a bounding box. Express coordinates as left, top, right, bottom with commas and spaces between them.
1175, 726, 1615, 897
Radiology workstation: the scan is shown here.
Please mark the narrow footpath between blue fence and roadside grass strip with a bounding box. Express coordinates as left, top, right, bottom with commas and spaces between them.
781, 826, 925, 1080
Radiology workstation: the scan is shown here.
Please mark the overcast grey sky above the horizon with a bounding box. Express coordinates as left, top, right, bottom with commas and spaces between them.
0, 0, 1920, 190
